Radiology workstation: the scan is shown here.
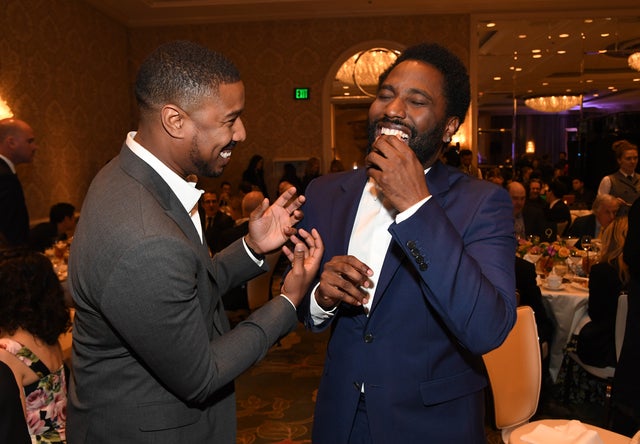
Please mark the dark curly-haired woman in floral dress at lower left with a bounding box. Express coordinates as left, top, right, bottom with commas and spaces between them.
0, 248, 71, 442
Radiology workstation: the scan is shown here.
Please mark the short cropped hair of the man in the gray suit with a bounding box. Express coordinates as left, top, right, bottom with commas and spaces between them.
135, 40, 240, 111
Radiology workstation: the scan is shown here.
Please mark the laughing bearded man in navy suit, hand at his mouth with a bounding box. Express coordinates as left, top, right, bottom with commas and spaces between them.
292, 44, 516, 444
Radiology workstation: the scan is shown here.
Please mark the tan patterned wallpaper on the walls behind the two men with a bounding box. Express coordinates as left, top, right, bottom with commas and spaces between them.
0, 0, 469, 219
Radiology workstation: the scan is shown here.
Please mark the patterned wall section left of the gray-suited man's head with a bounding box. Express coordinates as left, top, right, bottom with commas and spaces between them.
0, 0, 131, 221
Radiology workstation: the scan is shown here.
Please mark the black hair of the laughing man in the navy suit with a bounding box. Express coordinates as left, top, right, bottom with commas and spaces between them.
378, 43, 471, 124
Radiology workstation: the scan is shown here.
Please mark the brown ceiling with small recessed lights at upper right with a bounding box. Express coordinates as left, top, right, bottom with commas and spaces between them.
84, 0, 640, 113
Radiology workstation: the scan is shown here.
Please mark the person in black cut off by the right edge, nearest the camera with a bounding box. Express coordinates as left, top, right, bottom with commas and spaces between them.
611, 199, 640, 436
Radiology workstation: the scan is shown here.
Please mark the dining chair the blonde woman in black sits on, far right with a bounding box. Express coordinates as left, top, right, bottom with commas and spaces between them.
563, 292, 628, 425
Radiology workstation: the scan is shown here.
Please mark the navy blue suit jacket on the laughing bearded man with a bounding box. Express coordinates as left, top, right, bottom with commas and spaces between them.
300, 163, 516, 444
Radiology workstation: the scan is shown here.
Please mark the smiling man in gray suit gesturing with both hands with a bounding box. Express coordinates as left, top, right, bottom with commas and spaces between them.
67, 42, 323, 444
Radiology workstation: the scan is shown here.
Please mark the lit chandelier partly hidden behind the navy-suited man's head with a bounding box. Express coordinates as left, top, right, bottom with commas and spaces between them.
336, 48, 399, 97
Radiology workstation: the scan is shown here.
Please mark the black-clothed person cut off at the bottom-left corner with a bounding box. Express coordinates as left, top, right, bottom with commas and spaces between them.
0, 361, 31, 444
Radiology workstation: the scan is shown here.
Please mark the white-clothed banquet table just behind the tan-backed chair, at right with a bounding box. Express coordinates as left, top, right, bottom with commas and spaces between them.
539, 282, 589, 381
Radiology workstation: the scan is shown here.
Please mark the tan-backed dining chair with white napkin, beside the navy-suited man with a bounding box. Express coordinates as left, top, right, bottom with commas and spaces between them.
483, 306, 630, 444
